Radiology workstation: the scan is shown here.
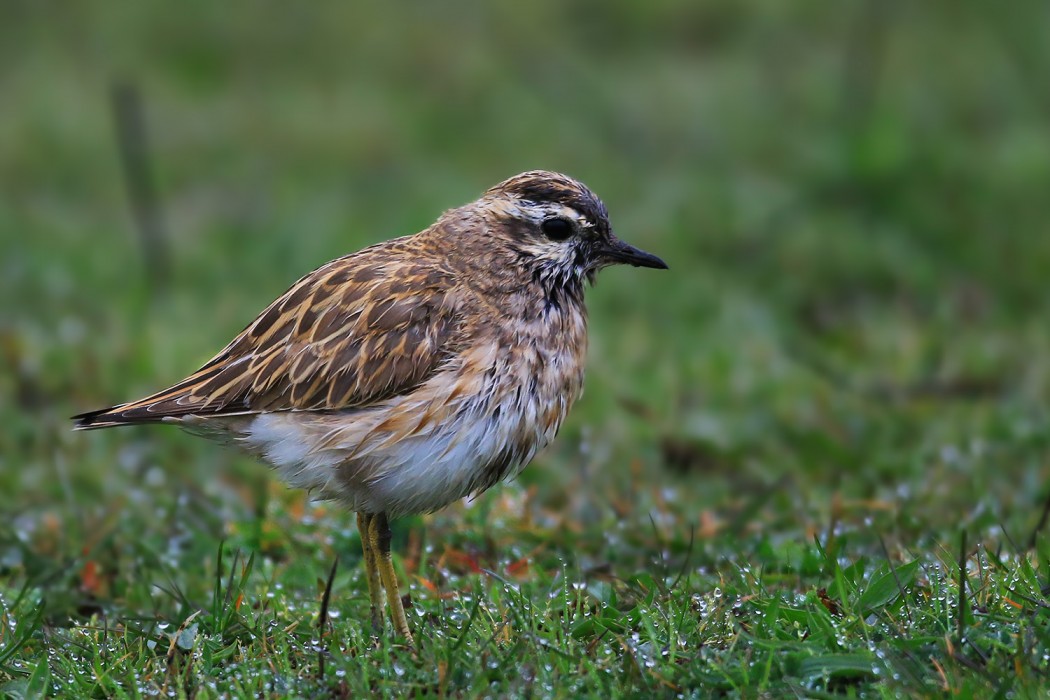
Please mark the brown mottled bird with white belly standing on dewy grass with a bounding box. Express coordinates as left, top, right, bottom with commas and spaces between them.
72, 170, 668, 648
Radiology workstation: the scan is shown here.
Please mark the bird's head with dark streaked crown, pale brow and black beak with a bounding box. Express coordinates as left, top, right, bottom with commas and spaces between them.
476, 170, 667, 287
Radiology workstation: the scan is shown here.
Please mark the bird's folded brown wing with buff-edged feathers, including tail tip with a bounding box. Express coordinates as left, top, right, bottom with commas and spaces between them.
75, 247, 455, 428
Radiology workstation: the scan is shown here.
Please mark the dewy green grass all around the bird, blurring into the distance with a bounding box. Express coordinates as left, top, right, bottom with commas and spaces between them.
0, 0, 1050, 698
